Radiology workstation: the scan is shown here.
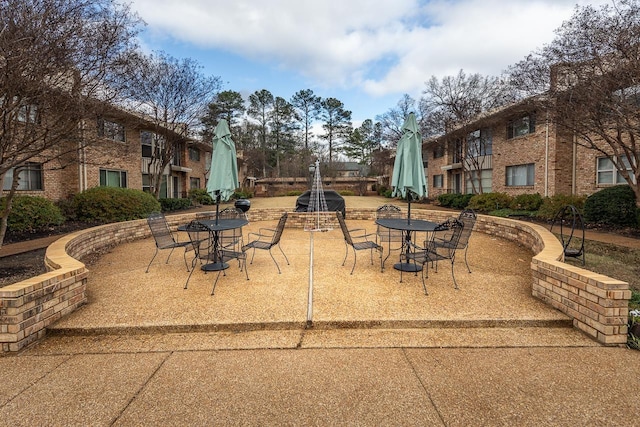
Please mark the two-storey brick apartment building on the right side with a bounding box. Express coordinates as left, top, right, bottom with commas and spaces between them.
423, 98, 626, 199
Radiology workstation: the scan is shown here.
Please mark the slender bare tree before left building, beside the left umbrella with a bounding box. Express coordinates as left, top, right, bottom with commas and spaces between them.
124, 52, 220, 198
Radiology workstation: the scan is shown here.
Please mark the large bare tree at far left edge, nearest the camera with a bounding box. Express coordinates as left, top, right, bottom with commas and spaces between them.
0, 0, 140, 245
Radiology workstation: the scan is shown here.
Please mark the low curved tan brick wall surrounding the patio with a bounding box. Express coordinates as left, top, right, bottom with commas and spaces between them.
0, 209, 631, 352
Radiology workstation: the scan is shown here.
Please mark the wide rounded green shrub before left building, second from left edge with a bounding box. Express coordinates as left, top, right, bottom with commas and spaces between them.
74, 187, 160, 223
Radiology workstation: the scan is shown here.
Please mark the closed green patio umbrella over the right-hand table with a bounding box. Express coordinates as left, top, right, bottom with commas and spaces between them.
391, 113, 427, 222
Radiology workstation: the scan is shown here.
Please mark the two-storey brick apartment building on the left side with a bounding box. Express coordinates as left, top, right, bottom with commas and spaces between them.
3, 106, 220, 201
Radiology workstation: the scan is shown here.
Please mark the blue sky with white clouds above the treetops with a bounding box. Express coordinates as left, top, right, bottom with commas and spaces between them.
126, 0, 610, 126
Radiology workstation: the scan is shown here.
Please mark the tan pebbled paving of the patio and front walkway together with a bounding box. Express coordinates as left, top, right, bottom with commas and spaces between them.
0, 200, 640, 426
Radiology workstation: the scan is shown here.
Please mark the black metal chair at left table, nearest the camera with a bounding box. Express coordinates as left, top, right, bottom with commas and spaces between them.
184, 220, 249, 295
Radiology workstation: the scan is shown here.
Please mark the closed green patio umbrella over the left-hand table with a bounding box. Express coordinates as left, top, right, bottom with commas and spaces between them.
207, 119, 238, 221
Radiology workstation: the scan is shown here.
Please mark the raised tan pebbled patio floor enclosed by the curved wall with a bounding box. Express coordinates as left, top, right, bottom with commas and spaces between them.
49, 203, 595, 346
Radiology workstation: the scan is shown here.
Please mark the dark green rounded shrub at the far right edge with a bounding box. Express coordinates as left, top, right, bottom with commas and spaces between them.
584, 185, 638, 227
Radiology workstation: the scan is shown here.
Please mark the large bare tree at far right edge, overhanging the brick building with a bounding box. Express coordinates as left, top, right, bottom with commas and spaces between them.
510, 0, 640, 207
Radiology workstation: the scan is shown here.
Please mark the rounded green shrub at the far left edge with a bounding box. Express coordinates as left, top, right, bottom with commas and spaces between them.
0, 196, 64, 232
